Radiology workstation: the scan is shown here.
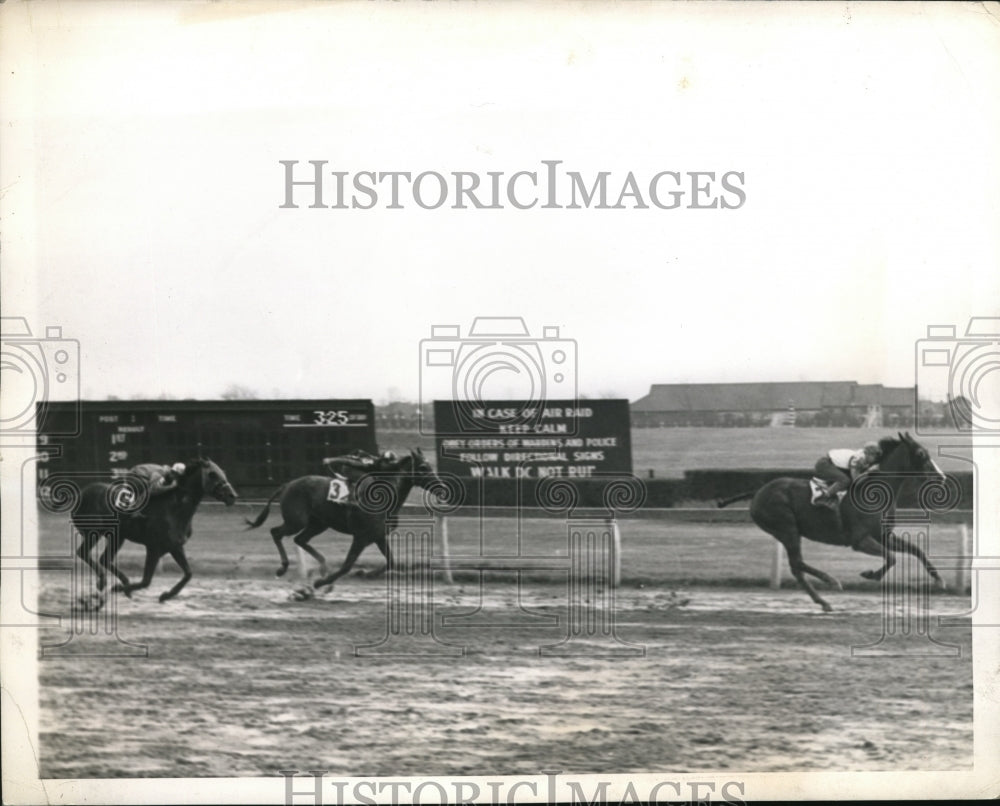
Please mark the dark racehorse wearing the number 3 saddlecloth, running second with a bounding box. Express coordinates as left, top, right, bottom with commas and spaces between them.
247, 448, 443, 588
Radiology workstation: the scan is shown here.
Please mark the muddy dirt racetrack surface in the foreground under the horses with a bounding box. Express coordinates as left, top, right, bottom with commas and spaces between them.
39, 507, 972, 778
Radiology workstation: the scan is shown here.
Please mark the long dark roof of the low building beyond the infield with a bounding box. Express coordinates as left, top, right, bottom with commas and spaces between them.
632, 381, 913, 412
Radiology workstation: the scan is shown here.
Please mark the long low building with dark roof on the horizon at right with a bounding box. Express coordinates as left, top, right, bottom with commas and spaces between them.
632, 381, 915, 428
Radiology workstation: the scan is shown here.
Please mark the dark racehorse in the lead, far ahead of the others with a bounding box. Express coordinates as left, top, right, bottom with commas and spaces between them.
718, 433, 945, 613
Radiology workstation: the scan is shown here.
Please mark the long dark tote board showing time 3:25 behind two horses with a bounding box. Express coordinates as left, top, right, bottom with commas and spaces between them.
38, 400, 376, 497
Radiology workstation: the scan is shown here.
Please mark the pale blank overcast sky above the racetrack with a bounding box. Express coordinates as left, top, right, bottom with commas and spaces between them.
0, 2, 1000, 401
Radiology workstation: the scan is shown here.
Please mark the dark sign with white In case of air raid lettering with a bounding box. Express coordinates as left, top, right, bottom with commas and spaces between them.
434, 400, 632, 479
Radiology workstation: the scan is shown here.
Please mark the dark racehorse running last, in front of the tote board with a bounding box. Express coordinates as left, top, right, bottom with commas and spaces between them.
71, 459, 238, 602
